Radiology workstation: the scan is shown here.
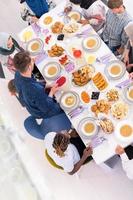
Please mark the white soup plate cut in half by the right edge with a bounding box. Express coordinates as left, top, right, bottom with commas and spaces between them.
123, 82, 133, 105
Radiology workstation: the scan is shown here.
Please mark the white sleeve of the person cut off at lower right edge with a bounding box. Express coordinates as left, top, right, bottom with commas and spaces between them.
121, 153, 133, 180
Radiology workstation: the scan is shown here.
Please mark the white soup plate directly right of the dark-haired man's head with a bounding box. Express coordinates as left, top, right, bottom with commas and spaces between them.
42, 62, 61, 80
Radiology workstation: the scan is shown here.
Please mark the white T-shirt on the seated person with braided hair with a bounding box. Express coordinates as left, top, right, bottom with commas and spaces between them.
44, 132, 80, 172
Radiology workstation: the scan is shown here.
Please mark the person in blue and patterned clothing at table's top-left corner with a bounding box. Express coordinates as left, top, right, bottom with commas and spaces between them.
19, 0, 49, 23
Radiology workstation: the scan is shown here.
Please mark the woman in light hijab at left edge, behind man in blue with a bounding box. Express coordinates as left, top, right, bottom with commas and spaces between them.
0, 32, 23, 72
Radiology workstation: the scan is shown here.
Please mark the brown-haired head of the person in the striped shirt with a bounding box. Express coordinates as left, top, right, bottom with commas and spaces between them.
108, 0, 125, 14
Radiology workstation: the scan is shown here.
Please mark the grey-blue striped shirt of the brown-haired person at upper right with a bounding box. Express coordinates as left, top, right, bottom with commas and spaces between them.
102, 9, 132, 47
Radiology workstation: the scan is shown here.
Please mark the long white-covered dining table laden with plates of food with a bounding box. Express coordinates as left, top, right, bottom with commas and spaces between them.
18, 1, 133, 168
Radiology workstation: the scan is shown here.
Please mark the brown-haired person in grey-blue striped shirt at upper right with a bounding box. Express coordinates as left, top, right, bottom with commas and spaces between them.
101, 0, 132, 54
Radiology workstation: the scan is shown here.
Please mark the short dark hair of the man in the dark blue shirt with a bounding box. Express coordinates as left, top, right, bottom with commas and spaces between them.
13, 51, 31, 73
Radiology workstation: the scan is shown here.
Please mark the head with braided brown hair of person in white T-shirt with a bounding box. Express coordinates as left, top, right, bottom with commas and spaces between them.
53, 133, 70, 157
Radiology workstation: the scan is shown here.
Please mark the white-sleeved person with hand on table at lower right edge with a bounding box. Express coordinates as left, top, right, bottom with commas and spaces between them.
115, 145, 133, 180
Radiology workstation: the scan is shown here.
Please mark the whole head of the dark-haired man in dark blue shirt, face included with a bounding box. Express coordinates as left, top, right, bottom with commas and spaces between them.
13, 51, 34, 74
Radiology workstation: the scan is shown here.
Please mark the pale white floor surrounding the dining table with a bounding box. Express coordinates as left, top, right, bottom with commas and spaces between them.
0, 0, 133, 200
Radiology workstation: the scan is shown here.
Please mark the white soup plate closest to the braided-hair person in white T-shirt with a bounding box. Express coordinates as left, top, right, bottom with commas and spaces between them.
78, 117, 99, 138
